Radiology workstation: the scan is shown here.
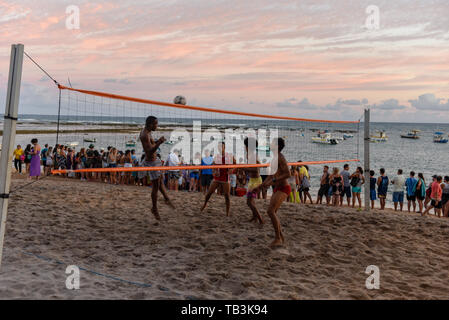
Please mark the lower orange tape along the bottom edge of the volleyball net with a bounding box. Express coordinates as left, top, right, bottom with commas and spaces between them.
51, 159, 360, 174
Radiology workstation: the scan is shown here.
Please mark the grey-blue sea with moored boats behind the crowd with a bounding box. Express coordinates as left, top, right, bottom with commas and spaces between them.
0, 115, 449, 208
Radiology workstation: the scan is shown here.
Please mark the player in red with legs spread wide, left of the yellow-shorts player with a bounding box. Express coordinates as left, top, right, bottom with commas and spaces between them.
201, 142, 236, 216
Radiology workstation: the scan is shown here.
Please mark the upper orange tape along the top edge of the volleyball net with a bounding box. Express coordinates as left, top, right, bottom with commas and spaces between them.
58, 84, 360, 123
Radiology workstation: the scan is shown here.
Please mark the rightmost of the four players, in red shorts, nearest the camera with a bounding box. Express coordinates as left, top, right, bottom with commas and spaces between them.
254, 138, 291, 248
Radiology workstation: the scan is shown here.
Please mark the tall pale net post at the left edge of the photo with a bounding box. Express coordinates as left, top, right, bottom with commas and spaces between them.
0, 44, 24, 268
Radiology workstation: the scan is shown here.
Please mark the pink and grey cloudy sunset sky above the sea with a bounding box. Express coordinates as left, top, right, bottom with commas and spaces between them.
0, 0, 449, 122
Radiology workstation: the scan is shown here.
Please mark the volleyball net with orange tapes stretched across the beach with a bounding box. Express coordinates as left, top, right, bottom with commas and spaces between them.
52, 85, 360, 174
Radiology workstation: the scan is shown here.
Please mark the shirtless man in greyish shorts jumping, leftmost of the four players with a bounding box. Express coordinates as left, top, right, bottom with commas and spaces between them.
139, 116, 175, 220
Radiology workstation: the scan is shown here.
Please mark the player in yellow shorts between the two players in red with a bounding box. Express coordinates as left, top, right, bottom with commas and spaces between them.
243, 138, 264, 224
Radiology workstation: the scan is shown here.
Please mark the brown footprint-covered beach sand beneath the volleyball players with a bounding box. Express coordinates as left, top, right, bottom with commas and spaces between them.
0, 176, 449, 299
